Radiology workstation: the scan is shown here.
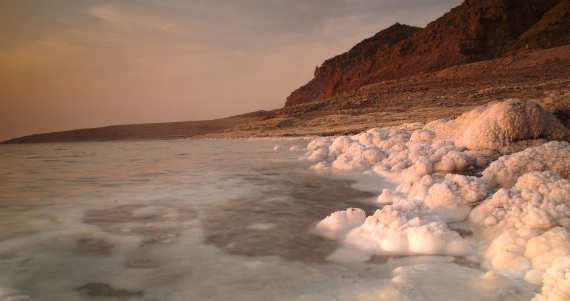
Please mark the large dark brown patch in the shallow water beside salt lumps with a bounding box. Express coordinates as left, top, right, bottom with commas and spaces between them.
202, 163, 378, 263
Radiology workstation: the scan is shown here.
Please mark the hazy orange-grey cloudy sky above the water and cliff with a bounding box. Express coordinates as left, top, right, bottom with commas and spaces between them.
0, 0, 462, 141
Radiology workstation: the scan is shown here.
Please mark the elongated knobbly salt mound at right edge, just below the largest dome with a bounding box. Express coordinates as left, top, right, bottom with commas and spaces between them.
483, 141, 570, 187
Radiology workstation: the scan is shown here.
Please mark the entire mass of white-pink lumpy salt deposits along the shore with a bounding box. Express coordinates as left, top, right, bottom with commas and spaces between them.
301, 100, 570, 300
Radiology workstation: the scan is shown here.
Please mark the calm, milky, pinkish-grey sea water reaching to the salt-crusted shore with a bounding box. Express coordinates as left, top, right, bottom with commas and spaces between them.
0, 140, 532, 301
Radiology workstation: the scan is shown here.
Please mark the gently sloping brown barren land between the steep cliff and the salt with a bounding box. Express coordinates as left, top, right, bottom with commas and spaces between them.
4, 46, 570, 144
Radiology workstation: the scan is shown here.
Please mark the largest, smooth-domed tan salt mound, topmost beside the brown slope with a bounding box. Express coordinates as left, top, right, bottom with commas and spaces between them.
424, 99, 570, 154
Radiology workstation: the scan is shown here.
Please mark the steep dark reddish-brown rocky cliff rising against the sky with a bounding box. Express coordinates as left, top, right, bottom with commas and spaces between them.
285, 0, 568, 106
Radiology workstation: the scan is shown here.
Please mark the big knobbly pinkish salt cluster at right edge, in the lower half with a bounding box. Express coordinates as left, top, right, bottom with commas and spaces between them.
464, 171, 570, 285
